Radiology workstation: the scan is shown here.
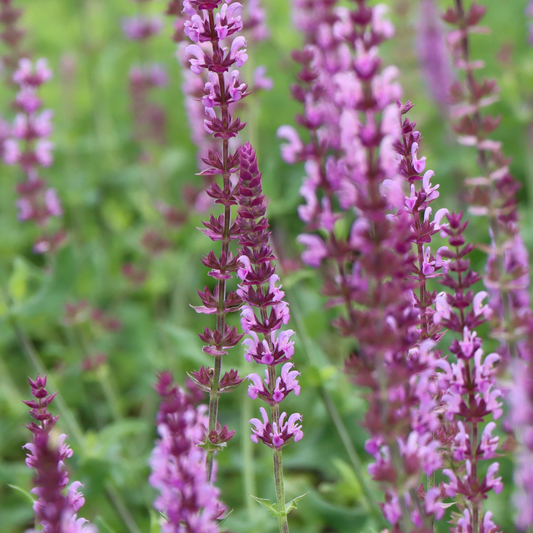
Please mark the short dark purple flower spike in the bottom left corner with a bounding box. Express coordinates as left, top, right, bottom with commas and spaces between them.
24, 375, 97, 533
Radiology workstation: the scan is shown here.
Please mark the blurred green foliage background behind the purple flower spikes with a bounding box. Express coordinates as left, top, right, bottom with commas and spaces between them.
0, 0, 533, 533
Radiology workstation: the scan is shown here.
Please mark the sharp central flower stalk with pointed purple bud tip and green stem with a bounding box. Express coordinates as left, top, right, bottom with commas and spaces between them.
237, 143, 303, 533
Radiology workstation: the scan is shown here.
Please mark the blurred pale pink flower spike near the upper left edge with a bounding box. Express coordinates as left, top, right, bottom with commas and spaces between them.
3, 59, 65, 253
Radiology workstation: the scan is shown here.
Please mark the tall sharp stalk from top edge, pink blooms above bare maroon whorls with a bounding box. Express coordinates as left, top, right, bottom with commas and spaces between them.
176, 0, 248, 480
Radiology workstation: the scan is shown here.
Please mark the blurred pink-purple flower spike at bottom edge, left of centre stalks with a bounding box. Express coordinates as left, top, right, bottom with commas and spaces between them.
149, 372, 226, 533
